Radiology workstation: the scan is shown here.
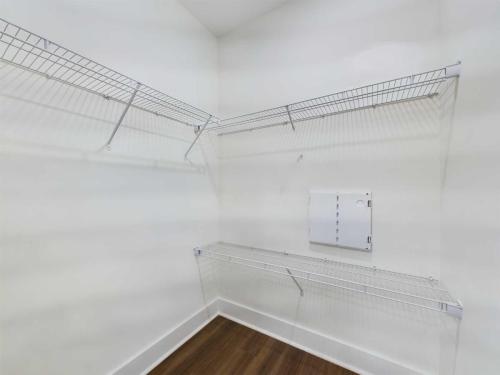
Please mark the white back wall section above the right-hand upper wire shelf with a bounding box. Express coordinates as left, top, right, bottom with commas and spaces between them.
219, 0, 446, 116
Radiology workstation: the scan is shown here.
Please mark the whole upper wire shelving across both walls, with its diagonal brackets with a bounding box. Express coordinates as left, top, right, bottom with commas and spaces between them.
0, 18, 460, 156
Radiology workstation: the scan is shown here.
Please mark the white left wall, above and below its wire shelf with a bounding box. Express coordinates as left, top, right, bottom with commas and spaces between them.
0, 0, 218, 375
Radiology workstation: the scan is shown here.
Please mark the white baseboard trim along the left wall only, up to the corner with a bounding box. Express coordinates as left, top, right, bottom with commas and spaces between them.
110, 299, 219, 375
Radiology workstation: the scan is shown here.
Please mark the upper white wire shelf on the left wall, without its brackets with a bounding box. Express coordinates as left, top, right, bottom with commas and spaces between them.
0, 18, 216, 126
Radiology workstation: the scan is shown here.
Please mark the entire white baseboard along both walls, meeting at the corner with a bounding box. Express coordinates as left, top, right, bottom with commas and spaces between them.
111, 298, 421, 375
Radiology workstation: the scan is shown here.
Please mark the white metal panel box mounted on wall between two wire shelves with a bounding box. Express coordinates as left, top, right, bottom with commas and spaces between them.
309, 191, 372, 251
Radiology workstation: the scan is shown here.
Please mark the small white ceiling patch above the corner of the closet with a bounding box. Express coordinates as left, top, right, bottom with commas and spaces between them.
179, 0, 288, 36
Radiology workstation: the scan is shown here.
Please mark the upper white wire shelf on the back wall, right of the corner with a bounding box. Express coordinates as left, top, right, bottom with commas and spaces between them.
209, 62, 460, 135
